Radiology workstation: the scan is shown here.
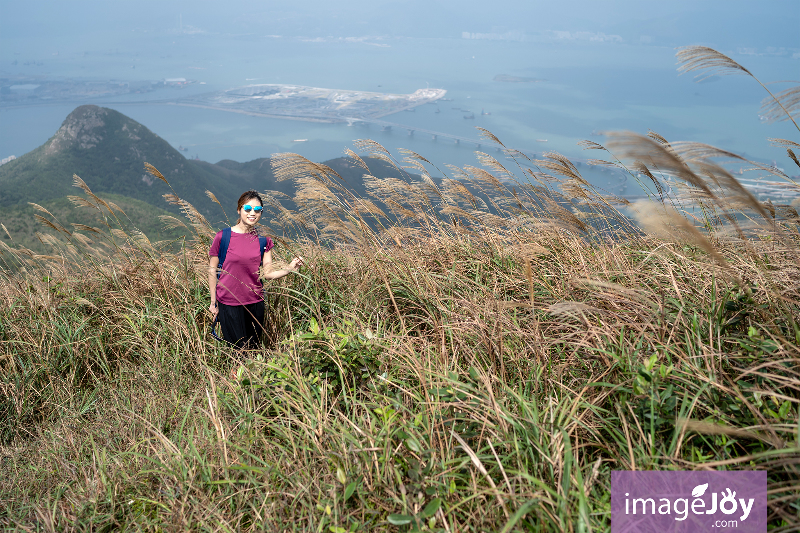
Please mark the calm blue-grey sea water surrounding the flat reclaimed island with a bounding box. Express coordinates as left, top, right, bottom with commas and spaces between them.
0, 34, 798, 194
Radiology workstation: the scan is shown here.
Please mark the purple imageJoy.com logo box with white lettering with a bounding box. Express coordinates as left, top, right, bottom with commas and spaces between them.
611, 470, 767, 533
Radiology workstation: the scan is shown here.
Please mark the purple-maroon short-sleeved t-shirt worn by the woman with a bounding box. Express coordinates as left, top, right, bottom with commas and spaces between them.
208, 231, 274, 305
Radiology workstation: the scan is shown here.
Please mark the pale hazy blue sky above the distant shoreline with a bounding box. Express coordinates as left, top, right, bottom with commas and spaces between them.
0, 0, 800, 48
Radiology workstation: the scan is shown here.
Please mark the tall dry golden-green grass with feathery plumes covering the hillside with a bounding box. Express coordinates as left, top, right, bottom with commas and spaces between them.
0, 47, 800, 533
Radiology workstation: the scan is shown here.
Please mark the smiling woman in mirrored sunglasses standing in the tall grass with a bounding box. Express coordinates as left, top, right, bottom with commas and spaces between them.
208, 191, 303, 348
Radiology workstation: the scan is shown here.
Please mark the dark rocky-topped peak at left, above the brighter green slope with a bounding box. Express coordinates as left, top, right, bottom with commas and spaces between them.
0, 105, 266, 214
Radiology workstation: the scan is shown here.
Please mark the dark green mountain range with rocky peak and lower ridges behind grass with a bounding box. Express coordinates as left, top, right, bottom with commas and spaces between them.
0, 105, 410, 250
